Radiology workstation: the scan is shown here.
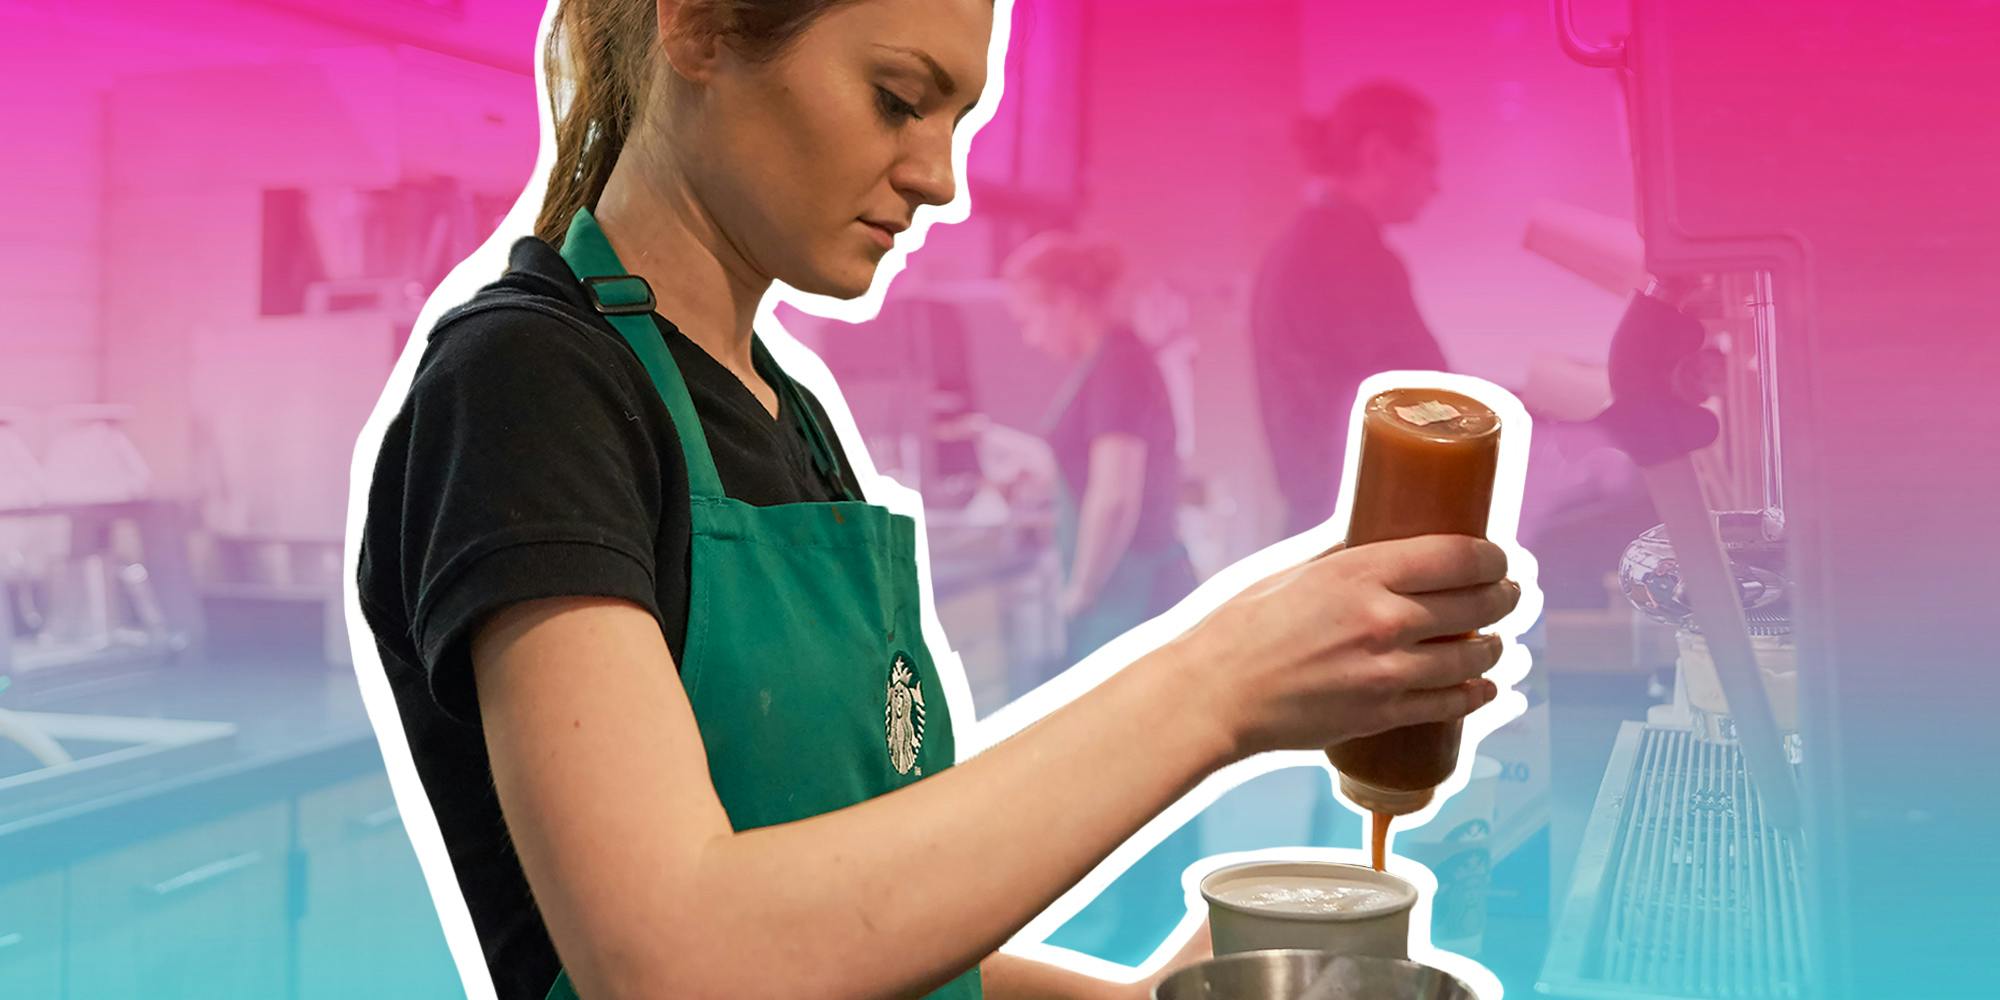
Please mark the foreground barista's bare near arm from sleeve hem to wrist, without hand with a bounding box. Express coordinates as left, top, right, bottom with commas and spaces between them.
472, 598, 1230, 1000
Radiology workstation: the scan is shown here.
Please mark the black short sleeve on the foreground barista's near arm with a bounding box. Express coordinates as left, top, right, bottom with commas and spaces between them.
386, 308, 686, 720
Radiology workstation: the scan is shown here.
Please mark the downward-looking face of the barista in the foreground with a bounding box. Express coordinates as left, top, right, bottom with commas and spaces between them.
678, 0, 994, 298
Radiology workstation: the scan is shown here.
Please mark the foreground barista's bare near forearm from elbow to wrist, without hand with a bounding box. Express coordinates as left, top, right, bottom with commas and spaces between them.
662, 646, 1232, 998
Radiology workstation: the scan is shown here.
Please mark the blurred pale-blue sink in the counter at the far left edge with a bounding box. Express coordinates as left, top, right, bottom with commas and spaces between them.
0, 712, 236, 826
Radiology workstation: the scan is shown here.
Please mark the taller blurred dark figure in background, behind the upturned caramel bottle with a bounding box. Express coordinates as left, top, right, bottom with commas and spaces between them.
1250, 80, 1446, 536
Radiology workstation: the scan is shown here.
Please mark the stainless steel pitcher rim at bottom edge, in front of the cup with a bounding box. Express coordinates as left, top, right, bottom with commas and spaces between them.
1152, 950, 1476, 1000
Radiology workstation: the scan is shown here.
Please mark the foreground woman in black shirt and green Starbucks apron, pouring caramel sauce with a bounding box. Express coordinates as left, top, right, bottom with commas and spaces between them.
360, 0, 1516, 1000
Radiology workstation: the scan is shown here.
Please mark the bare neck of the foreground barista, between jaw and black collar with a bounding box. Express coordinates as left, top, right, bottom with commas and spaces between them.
592, 146, 770, 388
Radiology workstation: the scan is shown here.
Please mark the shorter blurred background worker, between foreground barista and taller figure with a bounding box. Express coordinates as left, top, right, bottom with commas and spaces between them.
1004, 232, 1194, 662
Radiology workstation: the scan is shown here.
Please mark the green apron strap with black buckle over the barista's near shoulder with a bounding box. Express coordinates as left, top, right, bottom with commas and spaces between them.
562, 208, 722, 496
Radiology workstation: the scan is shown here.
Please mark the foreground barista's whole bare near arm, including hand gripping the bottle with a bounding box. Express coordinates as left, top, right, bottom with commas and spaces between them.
488, 536, 1520, 1000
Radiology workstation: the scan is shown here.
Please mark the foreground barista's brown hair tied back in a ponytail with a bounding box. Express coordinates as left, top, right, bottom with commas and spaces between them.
534, 0, 854, 246
